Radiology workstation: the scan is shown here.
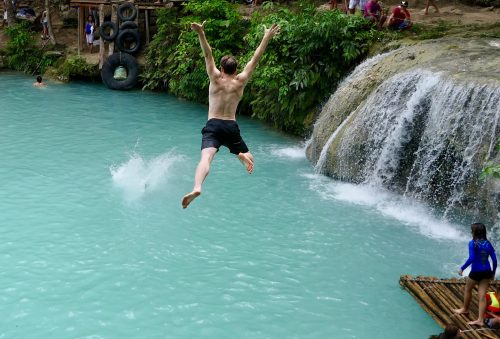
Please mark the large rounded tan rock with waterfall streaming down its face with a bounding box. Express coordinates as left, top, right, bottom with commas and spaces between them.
307, 39, 500, 223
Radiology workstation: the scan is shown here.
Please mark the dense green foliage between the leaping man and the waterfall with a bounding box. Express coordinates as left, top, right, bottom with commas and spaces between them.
243, 2, 380, 134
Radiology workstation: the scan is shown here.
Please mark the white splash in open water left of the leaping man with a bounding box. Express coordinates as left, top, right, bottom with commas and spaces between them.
109, 152, 182, 201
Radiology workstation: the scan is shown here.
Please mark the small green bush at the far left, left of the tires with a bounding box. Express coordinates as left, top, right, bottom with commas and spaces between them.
5, 22, 52, 73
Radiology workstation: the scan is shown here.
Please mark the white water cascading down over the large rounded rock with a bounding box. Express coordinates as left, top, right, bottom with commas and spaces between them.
308, 39, 500, 222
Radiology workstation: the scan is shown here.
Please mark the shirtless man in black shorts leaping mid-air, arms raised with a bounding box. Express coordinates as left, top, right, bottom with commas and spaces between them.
182, 22, 279, 208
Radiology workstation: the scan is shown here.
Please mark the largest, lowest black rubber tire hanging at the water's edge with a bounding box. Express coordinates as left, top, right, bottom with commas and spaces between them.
101, 52, 139, 91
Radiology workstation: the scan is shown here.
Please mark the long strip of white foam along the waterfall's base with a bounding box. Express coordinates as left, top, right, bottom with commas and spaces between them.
305, 174, 467, 241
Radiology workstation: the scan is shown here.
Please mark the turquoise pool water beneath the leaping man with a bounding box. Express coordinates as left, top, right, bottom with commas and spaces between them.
0, 73, 476, 339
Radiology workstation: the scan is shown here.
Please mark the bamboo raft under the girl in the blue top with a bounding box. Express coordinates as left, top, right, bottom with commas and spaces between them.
399, 275, 500, 339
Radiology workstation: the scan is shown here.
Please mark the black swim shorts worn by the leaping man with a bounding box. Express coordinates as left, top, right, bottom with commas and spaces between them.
201, 119, 248, 154
